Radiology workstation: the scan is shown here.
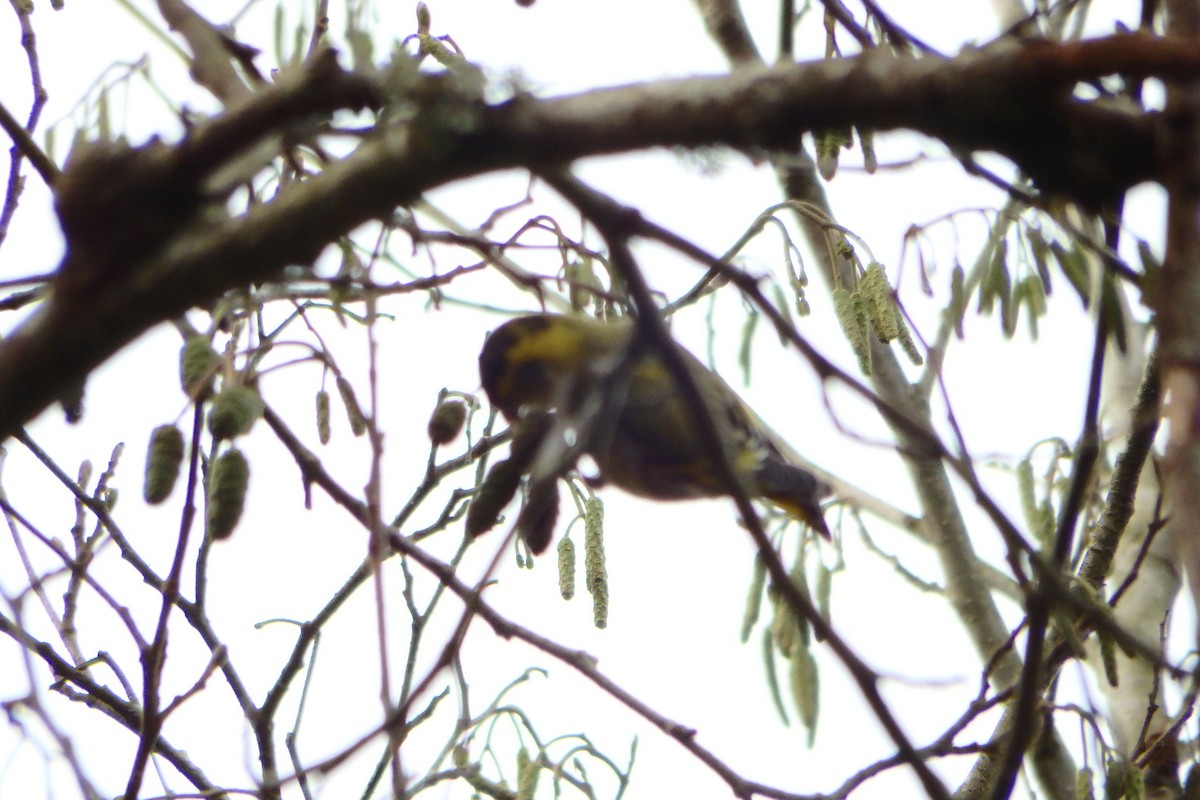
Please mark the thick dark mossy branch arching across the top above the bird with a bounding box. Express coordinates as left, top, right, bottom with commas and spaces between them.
0, 35, 1200, 443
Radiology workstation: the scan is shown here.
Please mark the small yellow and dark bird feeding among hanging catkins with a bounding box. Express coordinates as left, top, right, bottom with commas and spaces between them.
479, 314, 829, 539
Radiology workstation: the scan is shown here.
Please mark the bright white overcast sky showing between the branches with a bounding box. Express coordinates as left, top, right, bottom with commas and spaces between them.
0, 0, 1180, 800
